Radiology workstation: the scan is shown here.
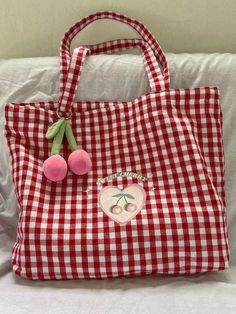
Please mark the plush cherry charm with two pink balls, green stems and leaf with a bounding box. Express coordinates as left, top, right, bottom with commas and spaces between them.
43, 118, 92, 182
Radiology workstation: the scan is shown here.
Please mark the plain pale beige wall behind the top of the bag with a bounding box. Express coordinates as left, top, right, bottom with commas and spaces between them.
0, 0, 236, 58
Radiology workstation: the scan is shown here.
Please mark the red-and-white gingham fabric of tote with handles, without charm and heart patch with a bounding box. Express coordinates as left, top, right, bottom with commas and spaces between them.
5, 12, 229, 279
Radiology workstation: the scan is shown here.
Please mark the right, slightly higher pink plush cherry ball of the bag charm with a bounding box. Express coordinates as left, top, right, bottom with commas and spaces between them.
68, 149, 92, 175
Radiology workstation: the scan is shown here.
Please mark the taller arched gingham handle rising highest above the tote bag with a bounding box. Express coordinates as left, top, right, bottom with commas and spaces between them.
60, 11, 170, 93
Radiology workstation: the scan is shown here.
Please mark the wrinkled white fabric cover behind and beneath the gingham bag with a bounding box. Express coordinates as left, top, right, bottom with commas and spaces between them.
0, 54, 236, 314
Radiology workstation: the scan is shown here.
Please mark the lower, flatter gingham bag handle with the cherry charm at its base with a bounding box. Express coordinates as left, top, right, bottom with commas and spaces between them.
58, 38, 165, 116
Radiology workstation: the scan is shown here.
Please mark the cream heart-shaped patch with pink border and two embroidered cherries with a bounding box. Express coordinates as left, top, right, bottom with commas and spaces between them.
98, 184, 146, 225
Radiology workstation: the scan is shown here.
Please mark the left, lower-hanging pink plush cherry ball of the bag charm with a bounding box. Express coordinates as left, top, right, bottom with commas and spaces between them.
43, 155, 67, 182
